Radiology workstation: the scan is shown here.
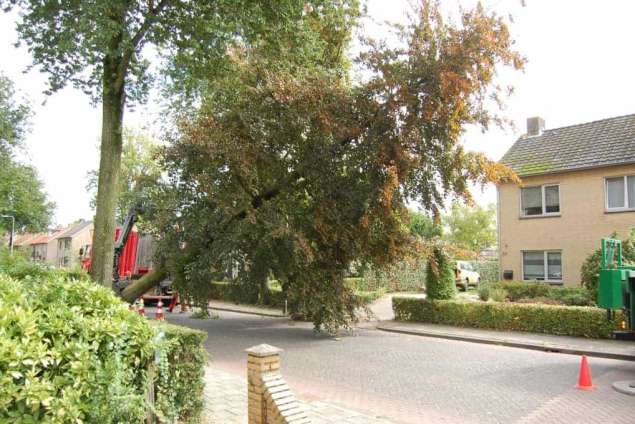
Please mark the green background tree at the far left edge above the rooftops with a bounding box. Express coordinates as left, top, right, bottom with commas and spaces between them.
0, 74, 54, 232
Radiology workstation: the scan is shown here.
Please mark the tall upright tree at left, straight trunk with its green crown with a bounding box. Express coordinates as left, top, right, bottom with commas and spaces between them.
0, 0, 357, 285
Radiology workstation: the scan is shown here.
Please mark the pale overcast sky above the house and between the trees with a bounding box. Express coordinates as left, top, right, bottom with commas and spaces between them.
0, 0, 635, 224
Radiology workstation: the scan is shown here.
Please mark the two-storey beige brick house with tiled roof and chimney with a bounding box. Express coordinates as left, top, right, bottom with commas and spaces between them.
497, 114, 635, 285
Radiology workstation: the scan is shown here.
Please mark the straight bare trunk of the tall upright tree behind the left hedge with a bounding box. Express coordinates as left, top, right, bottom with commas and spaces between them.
90, 57, 126, 287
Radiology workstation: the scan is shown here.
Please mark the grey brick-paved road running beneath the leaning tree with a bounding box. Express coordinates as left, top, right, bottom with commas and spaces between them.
169, 312, 635, 423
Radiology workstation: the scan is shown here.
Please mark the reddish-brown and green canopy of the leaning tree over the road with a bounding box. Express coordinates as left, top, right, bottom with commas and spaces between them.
140, 2, 523, 329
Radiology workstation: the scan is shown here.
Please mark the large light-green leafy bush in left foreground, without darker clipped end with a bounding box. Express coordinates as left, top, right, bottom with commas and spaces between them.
0, 274, 154, 423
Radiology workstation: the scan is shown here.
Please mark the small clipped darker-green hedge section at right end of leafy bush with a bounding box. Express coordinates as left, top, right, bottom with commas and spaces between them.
151, 321, 208, 422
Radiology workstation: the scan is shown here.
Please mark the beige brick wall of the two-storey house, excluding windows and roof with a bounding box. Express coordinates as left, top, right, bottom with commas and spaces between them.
498, 165, 635, 285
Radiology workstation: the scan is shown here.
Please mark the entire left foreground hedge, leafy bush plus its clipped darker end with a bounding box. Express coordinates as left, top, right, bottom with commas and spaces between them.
0, 261, 205, 423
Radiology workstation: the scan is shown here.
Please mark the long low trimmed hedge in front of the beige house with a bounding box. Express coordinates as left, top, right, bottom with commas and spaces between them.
392, 297, 622, 338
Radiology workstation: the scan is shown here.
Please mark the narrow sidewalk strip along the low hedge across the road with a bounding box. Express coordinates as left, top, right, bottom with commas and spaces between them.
377, 321, 635, 361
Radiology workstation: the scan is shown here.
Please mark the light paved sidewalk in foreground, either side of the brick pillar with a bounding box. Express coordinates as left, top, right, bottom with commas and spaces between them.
204, 366, 391, 424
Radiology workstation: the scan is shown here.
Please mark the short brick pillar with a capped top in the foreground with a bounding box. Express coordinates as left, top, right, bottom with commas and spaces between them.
245, 344, 282, 424
